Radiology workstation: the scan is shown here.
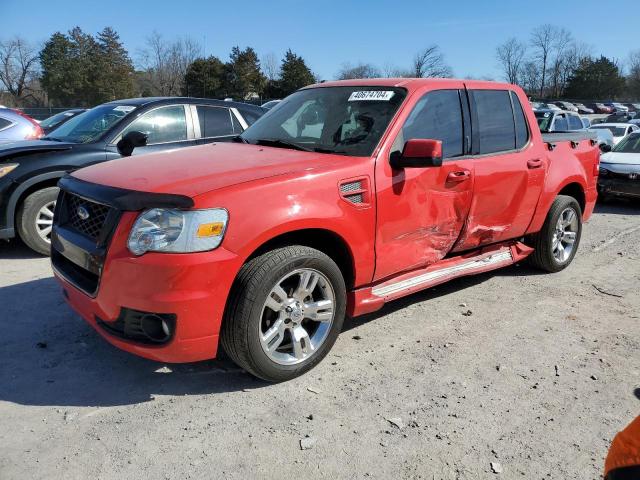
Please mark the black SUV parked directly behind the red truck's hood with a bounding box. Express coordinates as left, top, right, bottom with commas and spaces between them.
0, 97, 267, 254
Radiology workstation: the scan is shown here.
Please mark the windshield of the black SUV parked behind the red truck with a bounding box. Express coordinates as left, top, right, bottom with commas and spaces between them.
44, 105, 136, 143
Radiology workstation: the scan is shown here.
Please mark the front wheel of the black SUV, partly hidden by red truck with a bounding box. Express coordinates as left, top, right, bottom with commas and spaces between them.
16, 187, 59, 255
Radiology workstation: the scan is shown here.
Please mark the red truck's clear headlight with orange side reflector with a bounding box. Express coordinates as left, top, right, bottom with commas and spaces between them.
127, 208, 229, 255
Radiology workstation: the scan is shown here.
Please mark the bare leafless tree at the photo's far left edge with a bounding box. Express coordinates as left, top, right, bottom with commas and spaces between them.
0, 37, 38, 102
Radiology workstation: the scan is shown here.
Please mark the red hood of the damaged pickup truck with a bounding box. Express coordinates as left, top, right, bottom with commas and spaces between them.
73, 143, 345, 197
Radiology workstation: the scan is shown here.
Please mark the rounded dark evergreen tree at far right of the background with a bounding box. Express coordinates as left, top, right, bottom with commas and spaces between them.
564, 56, 625, 100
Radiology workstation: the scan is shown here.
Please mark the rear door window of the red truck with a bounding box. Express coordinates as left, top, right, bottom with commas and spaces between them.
473, 90, 516, 155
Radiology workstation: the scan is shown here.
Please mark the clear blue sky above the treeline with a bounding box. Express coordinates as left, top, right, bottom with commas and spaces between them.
0, 0, 640, 79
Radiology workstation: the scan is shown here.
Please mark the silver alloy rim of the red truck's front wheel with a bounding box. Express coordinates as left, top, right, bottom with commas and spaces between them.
258, 268, 335, 365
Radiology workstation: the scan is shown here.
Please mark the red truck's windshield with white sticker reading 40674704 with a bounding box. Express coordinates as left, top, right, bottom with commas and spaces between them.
241, 86, 406, 156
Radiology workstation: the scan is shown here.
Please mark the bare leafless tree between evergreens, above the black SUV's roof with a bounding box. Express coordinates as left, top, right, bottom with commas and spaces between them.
141, 32, 202, 96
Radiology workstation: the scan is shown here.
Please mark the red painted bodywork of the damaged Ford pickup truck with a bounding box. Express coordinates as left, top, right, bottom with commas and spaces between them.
58, 79, 599, 362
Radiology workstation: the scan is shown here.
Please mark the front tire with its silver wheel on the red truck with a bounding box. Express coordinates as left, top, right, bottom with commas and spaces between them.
220, 245, 346, 382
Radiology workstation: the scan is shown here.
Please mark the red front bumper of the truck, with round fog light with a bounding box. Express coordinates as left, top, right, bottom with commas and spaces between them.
52, 216, 242, 363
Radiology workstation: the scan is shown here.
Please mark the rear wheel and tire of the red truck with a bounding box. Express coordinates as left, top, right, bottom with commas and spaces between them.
527, 195, 582, 272
